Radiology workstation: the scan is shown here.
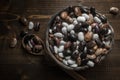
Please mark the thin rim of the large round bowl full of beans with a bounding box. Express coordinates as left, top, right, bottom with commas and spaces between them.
45, 5, 114, 71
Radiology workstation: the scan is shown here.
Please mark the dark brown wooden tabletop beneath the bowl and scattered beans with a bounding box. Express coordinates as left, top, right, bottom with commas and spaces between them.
0, 0, 120, 80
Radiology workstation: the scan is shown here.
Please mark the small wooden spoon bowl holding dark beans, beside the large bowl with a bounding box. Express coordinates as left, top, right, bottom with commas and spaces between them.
22, 34, 44, 55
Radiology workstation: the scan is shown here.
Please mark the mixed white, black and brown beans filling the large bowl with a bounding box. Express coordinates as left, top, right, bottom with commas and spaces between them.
48, 6, 114, 68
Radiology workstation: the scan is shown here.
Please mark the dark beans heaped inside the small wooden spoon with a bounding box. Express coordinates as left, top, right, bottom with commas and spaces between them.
23, 35, 43, 55
